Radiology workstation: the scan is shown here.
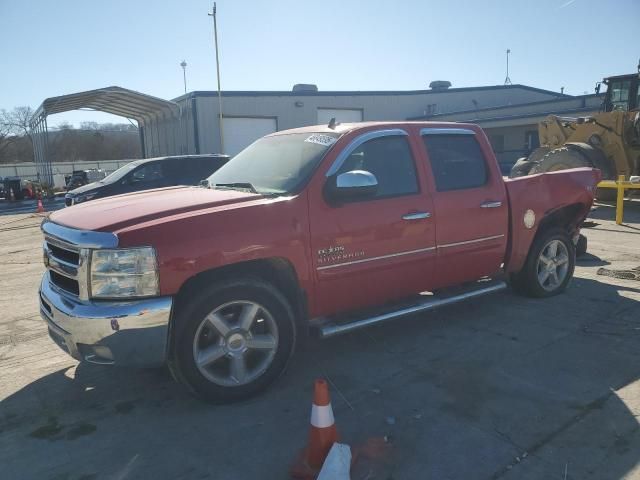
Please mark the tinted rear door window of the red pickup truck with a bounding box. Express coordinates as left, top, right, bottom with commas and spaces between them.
422, 135, 488, 192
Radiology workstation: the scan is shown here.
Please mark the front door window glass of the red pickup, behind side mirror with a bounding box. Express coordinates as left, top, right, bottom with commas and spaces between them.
338, 136, 418, 198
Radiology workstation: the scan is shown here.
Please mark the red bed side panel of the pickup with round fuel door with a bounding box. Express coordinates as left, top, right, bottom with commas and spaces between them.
505, 168, 601, 273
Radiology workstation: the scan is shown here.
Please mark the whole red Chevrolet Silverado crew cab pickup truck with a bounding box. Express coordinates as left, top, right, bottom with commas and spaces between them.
40, 122, 600, 402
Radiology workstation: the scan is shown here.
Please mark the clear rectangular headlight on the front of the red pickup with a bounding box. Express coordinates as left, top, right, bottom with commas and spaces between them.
91, 247, 160, 298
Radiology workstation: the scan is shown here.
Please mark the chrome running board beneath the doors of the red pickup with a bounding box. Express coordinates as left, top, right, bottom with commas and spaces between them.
311, 281, 507, 338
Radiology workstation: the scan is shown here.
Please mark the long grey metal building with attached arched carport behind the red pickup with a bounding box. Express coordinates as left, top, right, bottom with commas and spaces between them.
33, 81, 600, 181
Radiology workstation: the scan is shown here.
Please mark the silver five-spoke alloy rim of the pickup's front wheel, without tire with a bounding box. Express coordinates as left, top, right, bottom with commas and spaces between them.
193, 301, 278, 387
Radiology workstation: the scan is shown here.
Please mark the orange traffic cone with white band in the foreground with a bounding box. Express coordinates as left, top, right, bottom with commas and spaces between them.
291, 379, 338, 479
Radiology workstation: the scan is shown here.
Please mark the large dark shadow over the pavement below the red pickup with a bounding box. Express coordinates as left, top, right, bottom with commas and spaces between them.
0, 278, 640, 479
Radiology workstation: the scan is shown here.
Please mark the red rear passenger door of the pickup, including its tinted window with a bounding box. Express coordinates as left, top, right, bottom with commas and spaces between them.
420, 128, 509, 287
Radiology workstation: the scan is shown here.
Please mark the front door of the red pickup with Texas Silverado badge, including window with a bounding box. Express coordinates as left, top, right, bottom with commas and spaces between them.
310, 129, 435, 315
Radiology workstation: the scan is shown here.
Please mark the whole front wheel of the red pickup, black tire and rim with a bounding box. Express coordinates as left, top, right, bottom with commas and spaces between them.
171, 277, 296, 403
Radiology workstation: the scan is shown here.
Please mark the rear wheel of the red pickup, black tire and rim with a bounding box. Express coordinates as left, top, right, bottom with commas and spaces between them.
511, 228, 576, 298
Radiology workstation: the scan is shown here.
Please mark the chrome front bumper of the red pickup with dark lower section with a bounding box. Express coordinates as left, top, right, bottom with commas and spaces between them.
40, 273, 173, 367
